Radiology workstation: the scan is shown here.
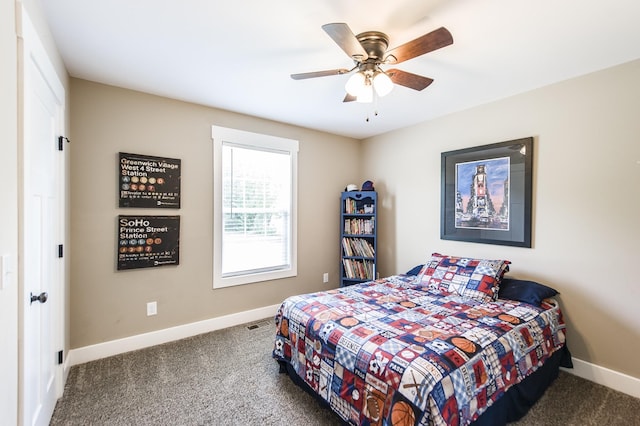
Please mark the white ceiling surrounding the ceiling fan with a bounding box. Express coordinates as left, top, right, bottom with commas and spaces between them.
42, 0, 640, 139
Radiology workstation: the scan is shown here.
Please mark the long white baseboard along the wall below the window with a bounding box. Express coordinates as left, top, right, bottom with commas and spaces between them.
65, 304, 280, 369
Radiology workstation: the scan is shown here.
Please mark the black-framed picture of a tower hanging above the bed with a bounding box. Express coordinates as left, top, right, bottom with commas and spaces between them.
440, 137, 533, 248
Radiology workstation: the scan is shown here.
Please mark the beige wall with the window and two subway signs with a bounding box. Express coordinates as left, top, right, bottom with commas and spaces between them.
70, 79, 361, 348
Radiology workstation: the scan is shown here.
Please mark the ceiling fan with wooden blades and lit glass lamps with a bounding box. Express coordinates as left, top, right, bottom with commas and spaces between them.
291, 23, 453, 102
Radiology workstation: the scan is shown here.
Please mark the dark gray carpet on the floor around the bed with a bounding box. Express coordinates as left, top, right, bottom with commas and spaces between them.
51, 318, 640, 426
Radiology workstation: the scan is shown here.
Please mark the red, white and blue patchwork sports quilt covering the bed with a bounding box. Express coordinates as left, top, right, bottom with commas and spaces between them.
273, 275, 565, 425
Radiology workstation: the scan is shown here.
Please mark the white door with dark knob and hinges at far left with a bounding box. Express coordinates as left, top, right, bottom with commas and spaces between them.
20, 10, 64, 425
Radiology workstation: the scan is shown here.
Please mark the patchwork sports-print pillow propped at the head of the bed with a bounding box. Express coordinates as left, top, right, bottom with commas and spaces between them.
415, 253, 511, 302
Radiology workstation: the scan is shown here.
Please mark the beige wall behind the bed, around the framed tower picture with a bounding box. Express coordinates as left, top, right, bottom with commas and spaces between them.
362, 61, 640, 378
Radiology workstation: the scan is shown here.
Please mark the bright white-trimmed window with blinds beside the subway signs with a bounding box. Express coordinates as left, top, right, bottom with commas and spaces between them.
211, 126, 298, 288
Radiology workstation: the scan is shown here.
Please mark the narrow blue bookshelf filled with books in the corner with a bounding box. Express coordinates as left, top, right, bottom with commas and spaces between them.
340, 191, 378, 287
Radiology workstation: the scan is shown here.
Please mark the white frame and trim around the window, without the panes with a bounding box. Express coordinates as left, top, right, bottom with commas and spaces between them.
211, 126, 298, 289
